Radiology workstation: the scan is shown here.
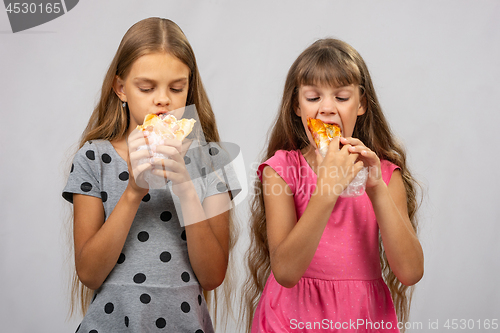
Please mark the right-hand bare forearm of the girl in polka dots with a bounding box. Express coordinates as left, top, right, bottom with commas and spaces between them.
181, 189, 229, 290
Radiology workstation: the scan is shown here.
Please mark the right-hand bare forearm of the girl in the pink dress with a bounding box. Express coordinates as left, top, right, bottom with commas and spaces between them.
367, 182, 423, 285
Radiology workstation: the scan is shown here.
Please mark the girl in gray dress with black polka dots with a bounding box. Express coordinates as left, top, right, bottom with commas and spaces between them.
63, 18, 240, 333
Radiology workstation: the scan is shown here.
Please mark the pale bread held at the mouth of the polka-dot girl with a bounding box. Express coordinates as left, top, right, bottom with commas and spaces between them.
137, 113, 196, 141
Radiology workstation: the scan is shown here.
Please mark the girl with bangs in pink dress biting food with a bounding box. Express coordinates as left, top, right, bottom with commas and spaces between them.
245, 39, 423, 333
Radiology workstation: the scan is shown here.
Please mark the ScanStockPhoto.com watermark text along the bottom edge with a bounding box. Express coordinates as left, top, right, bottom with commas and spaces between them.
290, 319, 423, 331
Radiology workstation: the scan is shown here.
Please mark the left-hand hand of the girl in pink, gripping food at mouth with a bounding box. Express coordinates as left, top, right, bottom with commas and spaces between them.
316, 138, 363, 197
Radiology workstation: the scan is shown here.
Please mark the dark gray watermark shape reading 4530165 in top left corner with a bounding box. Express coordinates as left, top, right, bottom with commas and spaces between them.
3, 0, 79, 32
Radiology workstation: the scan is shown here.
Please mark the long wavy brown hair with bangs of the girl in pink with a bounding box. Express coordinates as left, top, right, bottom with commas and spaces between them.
240, 39, 419, 331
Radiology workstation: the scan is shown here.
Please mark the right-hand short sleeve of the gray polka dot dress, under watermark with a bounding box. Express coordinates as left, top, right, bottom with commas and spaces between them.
205, 142, 241, 200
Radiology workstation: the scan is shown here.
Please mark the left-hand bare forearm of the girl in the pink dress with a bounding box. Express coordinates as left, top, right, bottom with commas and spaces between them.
270, 194, 338, 288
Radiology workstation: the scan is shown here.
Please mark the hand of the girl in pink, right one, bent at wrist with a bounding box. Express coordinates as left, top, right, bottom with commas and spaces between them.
340, 137, 383, 189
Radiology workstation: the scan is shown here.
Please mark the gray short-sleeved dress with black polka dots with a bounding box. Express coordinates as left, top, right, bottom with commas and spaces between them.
63, 140, 241, 333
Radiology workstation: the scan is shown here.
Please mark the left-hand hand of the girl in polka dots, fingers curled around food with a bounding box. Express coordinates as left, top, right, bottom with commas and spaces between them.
127, 130, 153, 196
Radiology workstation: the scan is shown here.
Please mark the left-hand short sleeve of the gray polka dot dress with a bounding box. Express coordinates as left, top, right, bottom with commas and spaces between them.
62, 141, 101, 203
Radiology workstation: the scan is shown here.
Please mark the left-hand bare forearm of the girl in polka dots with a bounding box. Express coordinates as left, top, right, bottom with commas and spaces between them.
75, 188, 142, 289
